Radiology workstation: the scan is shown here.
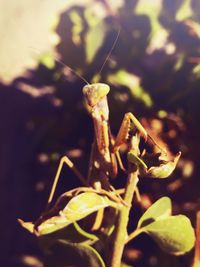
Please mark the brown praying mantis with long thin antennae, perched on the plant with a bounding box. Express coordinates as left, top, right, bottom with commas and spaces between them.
43, 30, 160, 216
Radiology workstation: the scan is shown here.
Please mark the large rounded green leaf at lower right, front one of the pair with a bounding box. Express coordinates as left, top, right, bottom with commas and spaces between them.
144, 215, 195, 255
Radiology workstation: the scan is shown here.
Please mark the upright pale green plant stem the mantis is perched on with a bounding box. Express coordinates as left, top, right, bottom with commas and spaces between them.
108, 167, 138, 267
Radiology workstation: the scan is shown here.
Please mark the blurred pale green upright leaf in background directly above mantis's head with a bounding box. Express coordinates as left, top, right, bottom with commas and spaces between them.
85, 21, 106, 64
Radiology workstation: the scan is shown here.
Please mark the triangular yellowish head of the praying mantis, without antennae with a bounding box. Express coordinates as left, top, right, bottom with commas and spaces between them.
83, 83, 110, 107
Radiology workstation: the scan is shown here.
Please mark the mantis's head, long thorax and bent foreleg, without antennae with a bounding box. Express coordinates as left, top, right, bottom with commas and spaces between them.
83, 83, 148, 186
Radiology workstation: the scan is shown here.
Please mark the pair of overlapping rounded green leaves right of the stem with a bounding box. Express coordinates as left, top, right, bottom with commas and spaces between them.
136, 197, 195, 255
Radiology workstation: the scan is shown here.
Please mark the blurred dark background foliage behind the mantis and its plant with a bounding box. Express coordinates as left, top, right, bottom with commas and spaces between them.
0, 0, 200, 267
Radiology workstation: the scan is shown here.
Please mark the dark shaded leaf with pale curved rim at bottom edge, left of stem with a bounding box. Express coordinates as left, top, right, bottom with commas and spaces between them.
44, 240, 105, 267
